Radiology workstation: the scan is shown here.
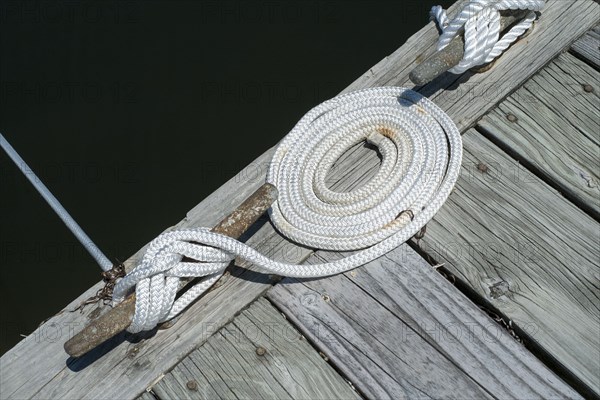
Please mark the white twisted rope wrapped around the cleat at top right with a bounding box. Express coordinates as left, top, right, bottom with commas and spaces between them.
431, 0, 545, 74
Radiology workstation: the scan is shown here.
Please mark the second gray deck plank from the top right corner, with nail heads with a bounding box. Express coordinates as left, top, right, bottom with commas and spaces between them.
479, 53, 600, 219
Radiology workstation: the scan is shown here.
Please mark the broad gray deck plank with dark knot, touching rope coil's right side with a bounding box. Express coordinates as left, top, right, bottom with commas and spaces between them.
420, 130, 600, 392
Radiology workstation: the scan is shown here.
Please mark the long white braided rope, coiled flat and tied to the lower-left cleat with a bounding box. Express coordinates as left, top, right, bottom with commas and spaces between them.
114, 87, 462, 332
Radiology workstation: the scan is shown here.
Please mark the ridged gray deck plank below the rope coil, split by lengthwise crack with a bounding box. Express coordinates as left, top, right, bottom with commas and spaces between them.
267, 244, 580, 399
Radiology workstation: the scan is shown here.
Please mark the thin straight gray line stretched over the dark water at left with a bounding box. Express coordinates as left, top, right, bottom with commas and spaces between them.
0, 133, 113, 271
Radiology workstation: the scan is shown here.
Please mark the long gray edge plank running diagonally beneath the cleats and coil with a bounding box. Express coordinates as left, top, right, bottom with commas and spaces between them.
0, 0, 599, 398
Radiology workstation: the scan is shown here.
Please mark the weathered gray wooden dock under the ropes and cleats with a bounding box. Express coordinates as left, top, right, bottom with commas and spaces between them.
0, 0, 600, 399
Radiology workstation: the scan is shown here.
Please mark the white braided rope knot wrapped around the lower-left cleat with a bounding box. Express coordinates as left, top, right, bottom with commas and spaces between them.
113, 228, 235, 333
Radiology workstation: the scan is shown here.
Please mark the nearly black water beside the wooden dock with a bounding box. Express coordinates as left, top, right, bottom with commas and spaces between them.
0, 0, 451, 353
